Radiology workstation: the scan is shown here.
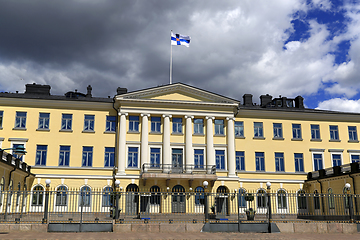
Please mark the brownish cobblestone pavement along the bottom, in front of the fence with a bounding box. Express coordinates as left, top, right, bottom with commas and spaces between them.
0, 232, 360, 240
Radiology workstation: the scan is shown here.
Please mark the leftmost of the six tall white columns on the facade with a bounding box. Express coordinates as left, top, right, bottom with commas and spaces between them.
118, 112, 128, 175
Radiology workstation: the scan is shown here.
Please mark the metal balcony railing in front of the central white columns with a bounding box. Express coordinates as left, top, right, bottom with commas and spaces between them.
142, 163, 216, 174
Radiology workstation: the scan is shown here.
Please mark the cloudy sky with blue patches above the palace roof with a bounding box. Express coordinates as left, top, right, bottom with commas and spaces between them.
0, 0, 360, 112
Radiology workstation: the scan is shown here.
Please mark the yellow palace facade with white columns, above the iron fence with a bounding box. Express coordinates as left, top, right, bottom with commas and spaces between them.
0, 83, 360, 201
